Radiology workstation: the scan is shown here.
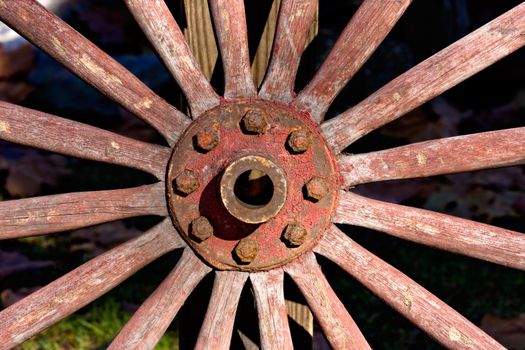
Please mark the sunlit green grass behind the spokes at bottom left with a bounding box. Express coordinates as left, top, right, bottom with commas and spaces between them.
16, 297, 179, 350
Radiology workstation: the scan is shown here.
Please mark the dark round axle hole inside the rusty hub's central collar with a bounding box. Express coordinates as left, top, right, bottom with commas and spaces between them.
233, 169, 273, 208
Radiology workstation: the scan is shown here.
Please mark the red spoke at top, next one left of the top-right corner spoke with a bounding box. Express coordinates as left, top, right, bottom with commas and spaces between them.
293, 0, 412, 121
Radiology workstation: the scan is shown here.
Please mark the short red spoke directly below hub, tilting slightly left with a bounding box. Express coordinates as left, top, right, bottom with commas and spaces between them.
195, 271, 248, 350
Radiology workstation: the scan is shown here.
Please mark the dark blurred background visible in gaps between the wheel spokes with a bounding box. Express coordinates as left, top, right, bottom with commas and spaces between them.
0, 0, 525, 349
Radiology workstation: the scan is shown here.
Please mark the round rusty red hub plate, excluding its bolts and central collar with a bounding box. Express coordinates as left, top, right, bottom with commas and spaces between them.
167, 100, 340, 271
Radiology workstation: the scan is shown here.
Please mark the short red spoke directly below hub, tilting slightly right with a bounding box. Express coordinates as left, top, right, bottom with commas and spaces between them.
250, 269, 293, 350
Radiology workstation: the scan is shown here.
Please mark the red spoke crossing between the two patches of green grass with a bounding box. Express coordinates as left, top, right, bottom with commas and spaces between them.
108, 248, 211, 350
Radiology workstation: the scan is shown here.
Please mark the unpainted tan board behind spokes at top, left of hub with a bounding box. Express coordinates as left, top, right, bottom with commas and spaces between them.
184, 0, 219, 80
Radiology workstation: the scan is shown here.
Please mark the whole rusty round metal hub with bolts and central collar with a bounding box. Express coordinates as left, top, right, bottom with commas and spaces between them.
167, 100, 340, 271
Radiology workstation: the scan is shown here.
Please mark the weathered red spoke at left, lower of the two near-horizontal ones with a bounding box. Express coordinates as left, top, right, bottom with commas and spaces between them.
0, 182, 168, 240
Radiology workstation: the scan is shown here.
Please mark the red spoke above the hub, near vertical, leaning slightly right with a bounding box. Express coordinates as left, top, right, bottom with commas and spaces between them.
259, 0, 317, 103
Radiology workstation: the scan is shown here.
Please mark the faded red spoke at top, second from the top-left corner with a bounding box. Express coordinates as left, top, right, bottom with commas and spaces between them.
125, 0, 219, 118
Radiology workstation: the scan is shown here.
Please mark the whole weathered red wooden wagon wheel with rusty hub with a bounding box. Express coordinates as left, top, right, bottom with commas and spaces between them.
0, 0, 525, 349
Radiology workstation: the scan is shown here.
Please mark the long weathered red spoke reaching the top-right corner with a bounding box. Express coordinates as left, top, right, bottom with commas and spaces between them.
322, 3, 525, 152
